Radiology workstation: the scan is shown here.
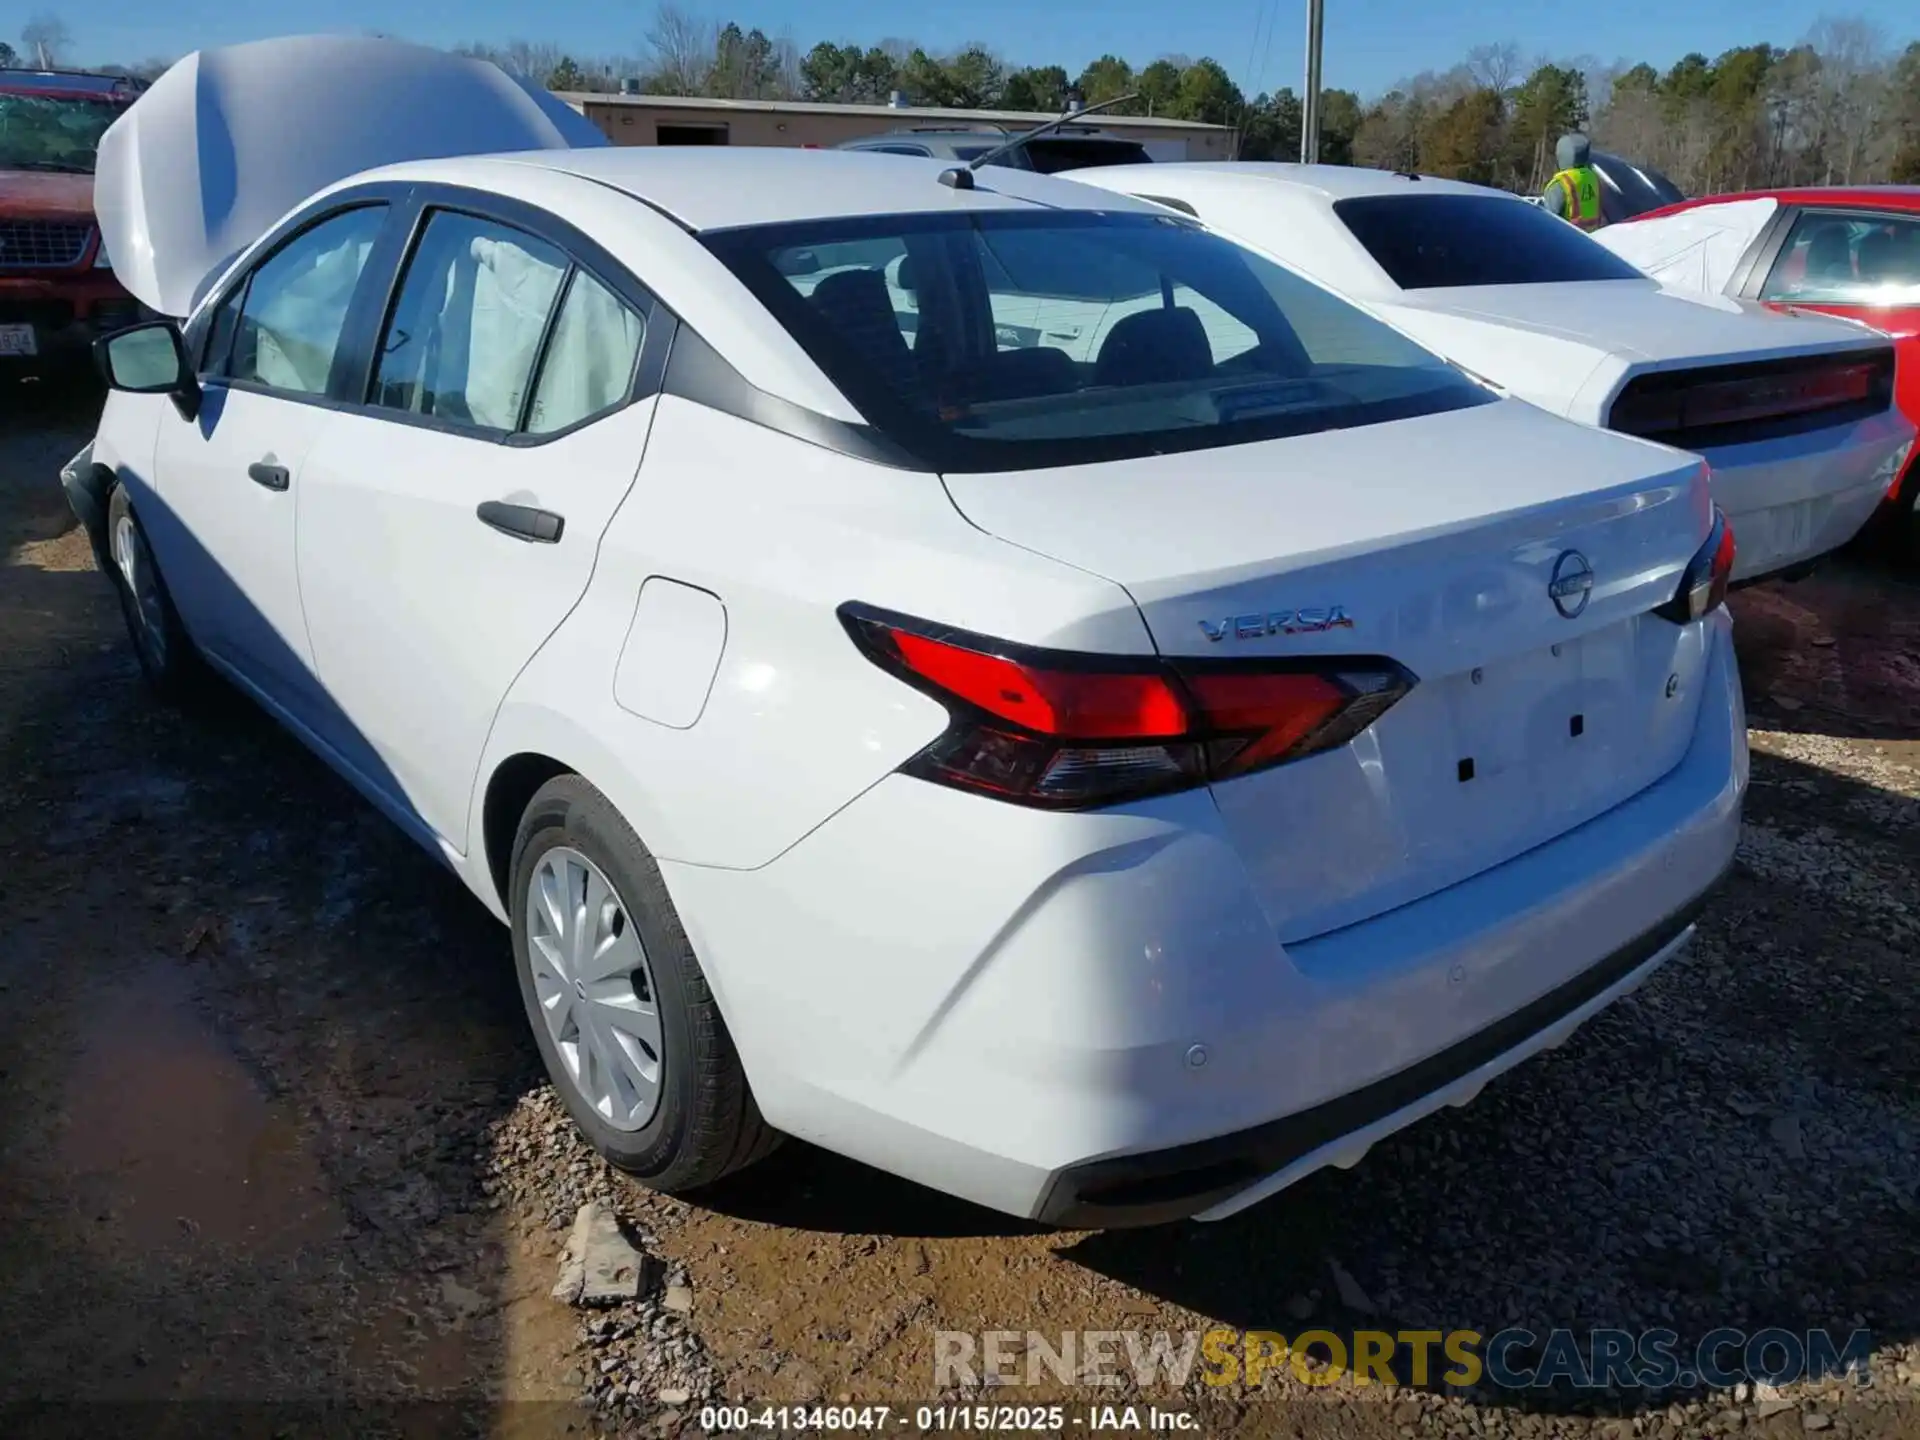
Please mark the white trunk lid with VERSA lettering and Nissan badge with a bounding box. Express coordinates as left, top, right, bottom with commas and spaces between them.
947, 401, 1711, 939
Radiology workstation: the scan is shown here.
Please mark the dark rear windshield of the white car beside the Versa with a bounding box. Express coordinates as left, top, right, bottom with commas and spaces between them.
1332, 194, 1647, 290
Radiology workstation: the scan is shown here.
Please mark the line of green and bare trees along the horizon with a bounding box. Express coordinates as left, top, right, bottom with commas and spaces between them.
37, 4, 1920, 194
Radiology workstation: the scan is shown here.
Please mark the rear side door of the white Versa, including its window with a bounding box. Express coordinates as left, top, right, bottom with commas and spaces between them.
298, 209, 664, 851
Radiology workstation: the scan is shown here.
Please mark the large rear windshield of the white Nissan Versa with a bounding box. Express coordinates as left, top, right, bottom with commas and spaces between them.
705, 211, 1492, 470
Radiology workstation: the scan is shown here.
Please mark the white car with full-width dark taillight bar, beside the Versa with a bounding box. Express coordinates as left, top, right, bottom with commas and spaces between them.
1066, 163, 1912, 580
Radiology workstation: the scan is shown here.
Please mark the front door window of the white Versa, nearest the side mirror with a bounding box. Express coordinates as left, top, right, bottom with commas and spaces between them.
219, 205, 386, 396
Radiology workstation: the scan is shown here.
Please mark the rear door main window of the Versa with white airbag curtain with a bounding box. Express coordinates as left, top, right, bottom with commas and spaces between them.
372, 211, 568, 430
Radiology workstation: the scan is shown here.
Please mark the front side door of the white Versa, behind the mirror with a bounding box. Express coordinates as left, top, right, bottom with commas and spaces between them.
140, 205, 388, 720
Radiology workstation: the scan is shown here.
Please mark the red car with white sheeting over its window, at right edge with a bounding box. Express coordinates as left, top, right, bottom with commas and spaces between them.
1596, 184, 1920, 557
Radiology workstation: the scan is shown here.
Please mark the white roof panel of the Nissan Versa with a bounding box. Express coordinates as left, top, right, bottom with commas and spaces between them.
355, 146, 1158, 230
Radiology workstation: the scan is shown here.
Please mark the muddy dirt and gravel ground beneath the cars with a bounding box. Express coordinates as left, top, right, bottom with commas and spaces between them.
0, 386, 1920, 1440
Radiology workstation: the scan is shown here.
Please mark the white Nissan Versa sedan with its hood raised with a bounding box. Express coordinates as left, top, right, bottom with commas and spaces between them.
65, 40, 1747, 1225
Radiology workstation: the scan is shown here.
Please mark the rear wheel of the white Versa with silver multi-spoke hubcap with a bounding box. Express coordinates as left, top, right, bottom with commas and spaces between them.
509, 776, 780, 1194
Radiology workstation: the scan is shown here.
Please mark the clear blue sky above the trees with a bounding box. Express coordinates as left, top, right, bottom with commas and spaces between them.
63, 0, 1920, 96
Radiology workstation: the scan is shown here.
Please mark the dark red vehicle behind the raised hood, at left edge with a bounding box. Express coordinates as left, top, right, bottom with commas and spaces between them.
0, 69, 144, 371
